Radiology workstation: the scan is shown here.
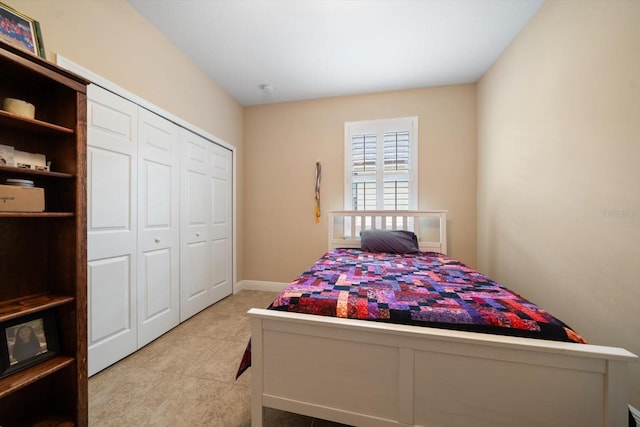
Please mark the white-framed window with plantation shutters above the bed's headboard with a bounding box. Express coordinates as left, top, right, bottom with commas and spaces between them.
344, 117, 418, 210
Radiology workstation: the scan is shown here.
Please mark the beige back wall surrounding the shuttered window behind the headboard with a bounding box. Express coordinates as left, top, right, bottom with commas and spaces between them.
244, 85, 476, 282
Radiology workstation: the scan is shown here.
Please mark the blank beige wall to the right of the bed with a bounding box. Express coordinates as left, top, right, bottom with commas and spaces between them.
478, 1, 640, 407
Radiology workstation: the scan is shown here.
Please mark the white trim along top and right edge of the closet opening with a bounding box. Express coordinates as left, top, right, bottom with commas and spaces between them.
56, 54, 238, 293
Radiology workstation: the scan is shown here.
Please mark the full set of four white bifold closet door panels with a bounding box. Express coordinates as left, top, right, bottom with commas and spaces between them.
87, 84, 233, 375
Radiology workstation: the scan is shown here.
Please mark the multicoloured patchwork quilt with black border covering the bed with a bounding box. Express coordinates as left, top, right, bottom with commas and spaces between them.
238, 249, 585, 376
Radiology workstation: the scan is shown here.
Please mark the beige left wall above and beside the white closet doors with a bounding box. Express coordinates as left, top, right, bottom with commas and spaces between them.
10, 0, 244, 280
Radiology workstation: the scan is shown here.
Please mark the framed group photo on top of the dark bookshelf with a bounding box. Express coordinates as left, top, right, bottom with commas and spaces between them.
0, 2, 45, 58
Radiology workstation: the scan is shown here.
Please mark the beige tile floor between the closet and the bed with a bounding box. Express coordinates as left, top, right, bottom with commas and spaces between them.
89, 291, 350, 427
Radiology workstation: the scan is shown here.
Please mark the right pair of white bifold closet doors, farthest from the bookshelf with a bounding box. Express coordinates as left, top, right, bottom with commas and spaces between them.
180, 129, 233, 321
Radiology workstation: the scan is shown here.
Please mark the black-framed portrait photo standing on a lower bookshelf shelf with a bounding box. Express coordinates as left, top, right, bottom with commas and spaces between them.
0, 310, 60, 378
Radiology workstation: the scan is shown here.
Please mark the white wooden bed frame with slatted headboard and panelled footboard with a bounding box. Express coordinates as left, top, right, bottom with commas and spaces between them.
249, 211, 637, 427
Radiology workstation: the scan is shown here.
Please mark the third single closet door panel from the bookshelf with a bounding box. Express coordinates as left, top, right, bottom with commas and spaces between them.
180, 129, 211, 321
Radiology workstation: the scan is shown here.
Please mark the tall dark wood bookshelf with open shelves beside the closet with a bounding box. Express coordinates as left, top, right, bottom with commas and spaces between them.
0, 37, 89, 427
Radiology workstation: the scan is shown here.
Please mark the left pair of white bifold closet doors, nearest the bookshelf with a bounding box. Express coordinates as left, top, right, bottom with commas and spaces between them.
87, 85, 180, 375
